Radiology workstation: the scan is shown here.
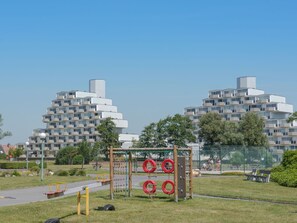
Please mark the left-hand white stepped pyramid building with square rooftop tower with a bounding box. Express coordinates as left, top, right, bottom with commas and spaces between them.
29, 80, 138, 158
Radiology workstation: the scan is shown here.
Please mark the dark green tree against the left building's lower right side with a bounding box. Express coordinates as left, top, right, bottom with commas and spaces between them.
97, 118, 120, 158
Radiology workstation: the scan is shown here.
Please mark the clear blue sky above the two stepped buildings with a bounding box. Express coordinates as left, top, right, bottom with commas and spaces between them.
0, 0, 297, 144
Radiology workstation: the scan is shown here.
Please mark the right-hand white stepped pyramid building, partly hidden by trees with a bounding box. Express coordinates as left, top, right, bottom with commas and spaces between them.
184, 77, 297, 159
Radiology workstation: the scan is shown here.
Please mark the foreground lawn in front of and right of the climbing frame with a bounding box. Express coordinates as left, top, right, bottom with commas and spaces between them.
0, 176, 297, 223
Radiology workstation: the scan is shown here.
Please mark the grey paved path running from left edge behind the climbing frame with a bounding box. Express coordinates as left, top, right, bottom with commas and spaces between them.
0, 176, 161, 207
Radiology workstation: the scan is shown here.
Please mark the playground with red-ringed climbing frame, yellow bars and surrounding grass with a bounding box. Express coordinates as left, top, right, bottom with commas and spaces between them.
0, 146, 297, 223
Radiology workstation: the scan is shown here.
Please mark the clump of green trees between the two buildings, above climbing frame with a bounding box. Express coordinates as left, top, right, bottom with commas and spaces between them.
138, 114, 196, 148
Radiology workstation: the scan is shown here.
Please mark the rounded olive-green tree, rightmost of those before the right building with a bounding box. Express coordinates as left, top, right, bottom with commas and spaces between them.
239, 112, 268, 147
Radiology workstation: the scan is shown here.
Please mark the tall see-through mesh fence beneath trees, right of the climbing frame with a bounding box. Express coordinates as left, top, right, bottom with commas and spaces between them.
193, 146, 279, 172
